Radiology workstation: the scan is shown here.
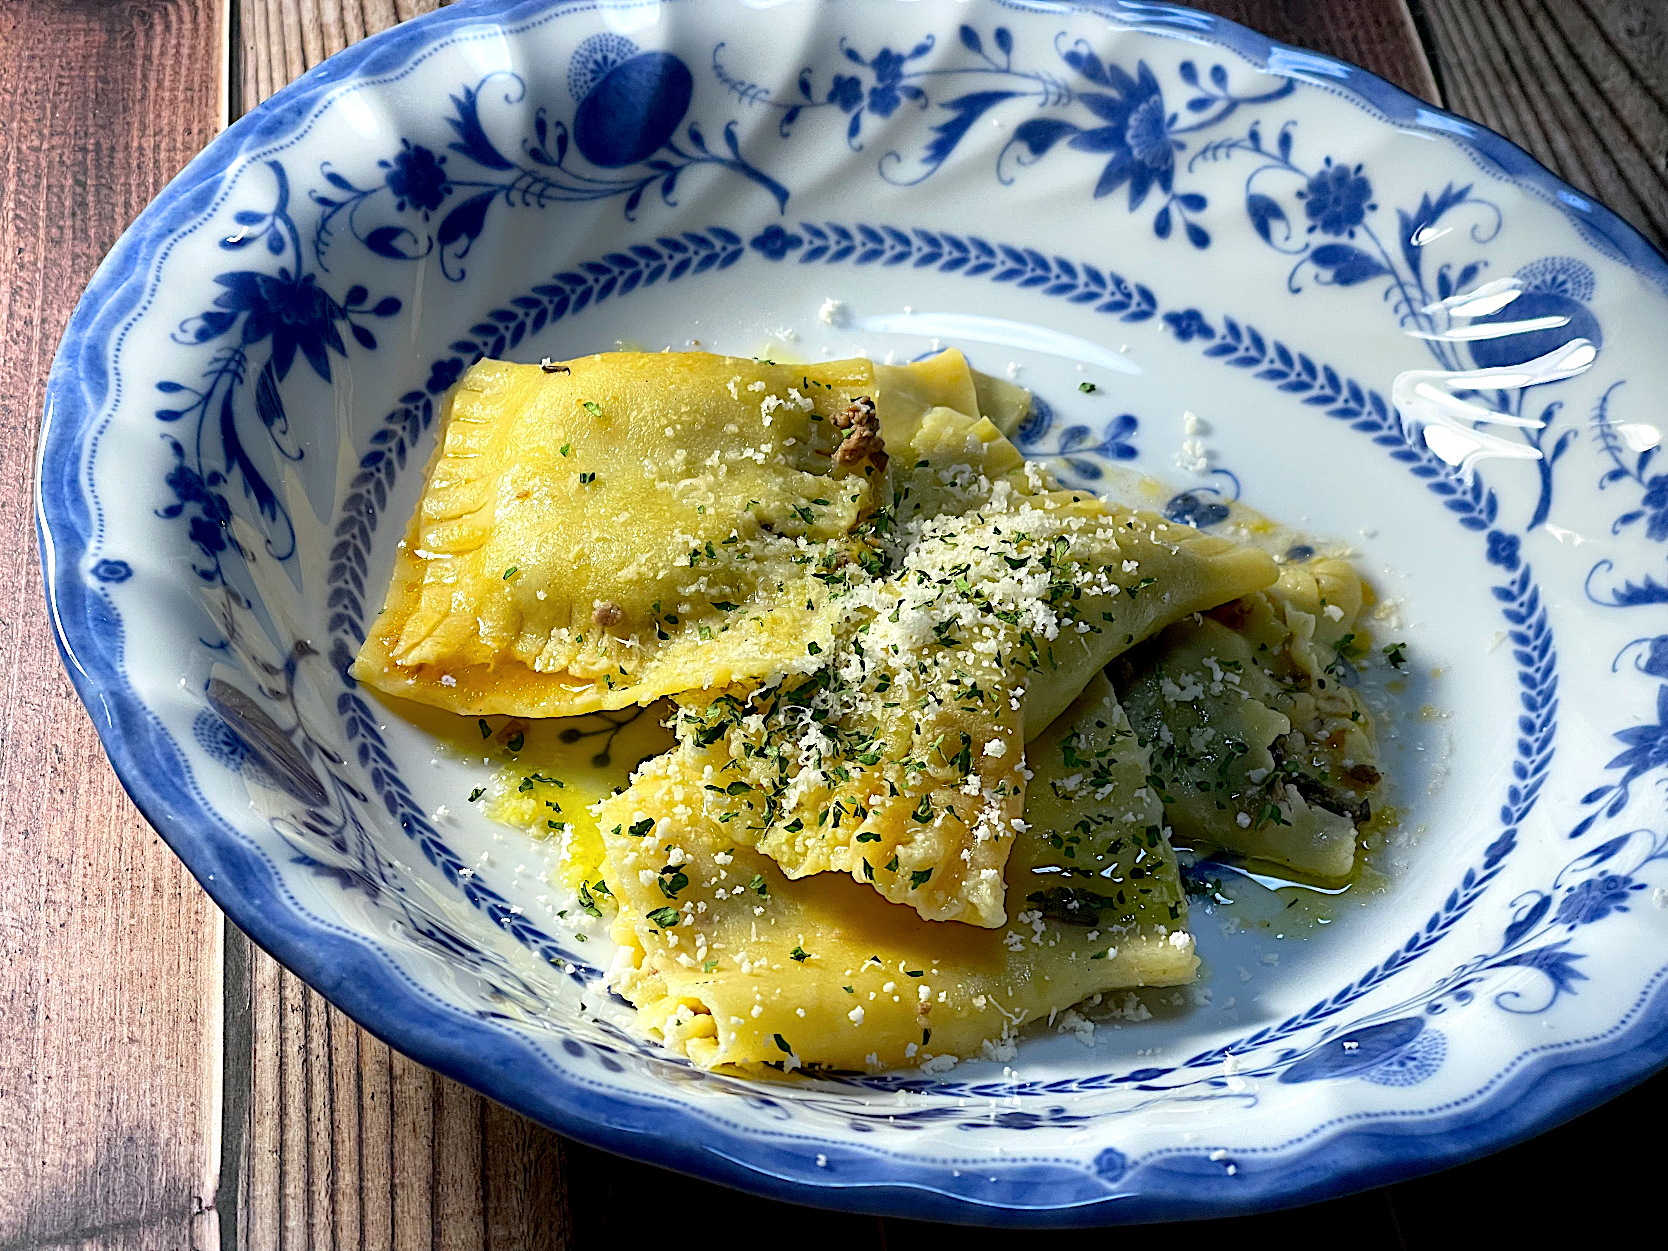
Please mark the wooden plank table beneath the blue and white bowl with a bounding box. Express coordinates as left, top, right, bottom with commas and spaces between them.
0, 0, 1668, 1251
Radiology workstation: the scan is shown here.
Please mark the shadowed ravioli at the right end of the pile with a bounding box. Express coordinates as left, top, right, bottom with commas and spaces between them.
1114, 559, 1383, 879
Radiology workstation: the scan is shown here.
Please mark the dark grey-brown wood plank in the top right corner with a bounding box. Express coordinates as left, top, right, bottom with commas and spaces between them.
1423, 0, 1668, 249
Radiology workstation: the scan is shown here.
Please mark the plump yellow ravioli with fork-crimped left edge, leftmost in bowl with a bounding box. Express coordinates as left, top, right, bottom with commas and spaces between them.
354, 352, 874, 717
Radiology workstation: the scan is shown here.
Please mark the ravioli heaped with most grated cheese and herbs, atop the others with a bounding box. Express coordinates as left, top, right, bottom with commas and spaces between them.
653, 409, 1274, 927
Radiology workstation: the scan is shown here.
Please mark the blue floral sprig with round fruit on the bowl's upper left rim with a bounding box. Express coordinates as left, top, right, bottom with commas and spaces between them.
312, 33, 787, 282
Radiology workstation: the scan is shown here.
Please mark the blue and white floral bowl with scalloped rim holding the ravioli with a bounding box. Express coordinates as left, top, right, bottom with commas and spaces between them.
40, 0, 1668, 1224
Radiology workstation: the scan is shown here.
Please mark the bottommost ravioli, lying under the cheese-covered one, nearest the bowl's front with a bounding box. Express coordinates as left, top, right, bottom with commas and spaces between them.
599, 679, 1198, 1071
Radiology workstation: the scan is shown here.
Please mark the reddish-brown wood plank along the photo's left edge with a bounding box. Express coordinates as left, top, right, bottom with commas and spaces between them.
0, 0, 224, 1251
